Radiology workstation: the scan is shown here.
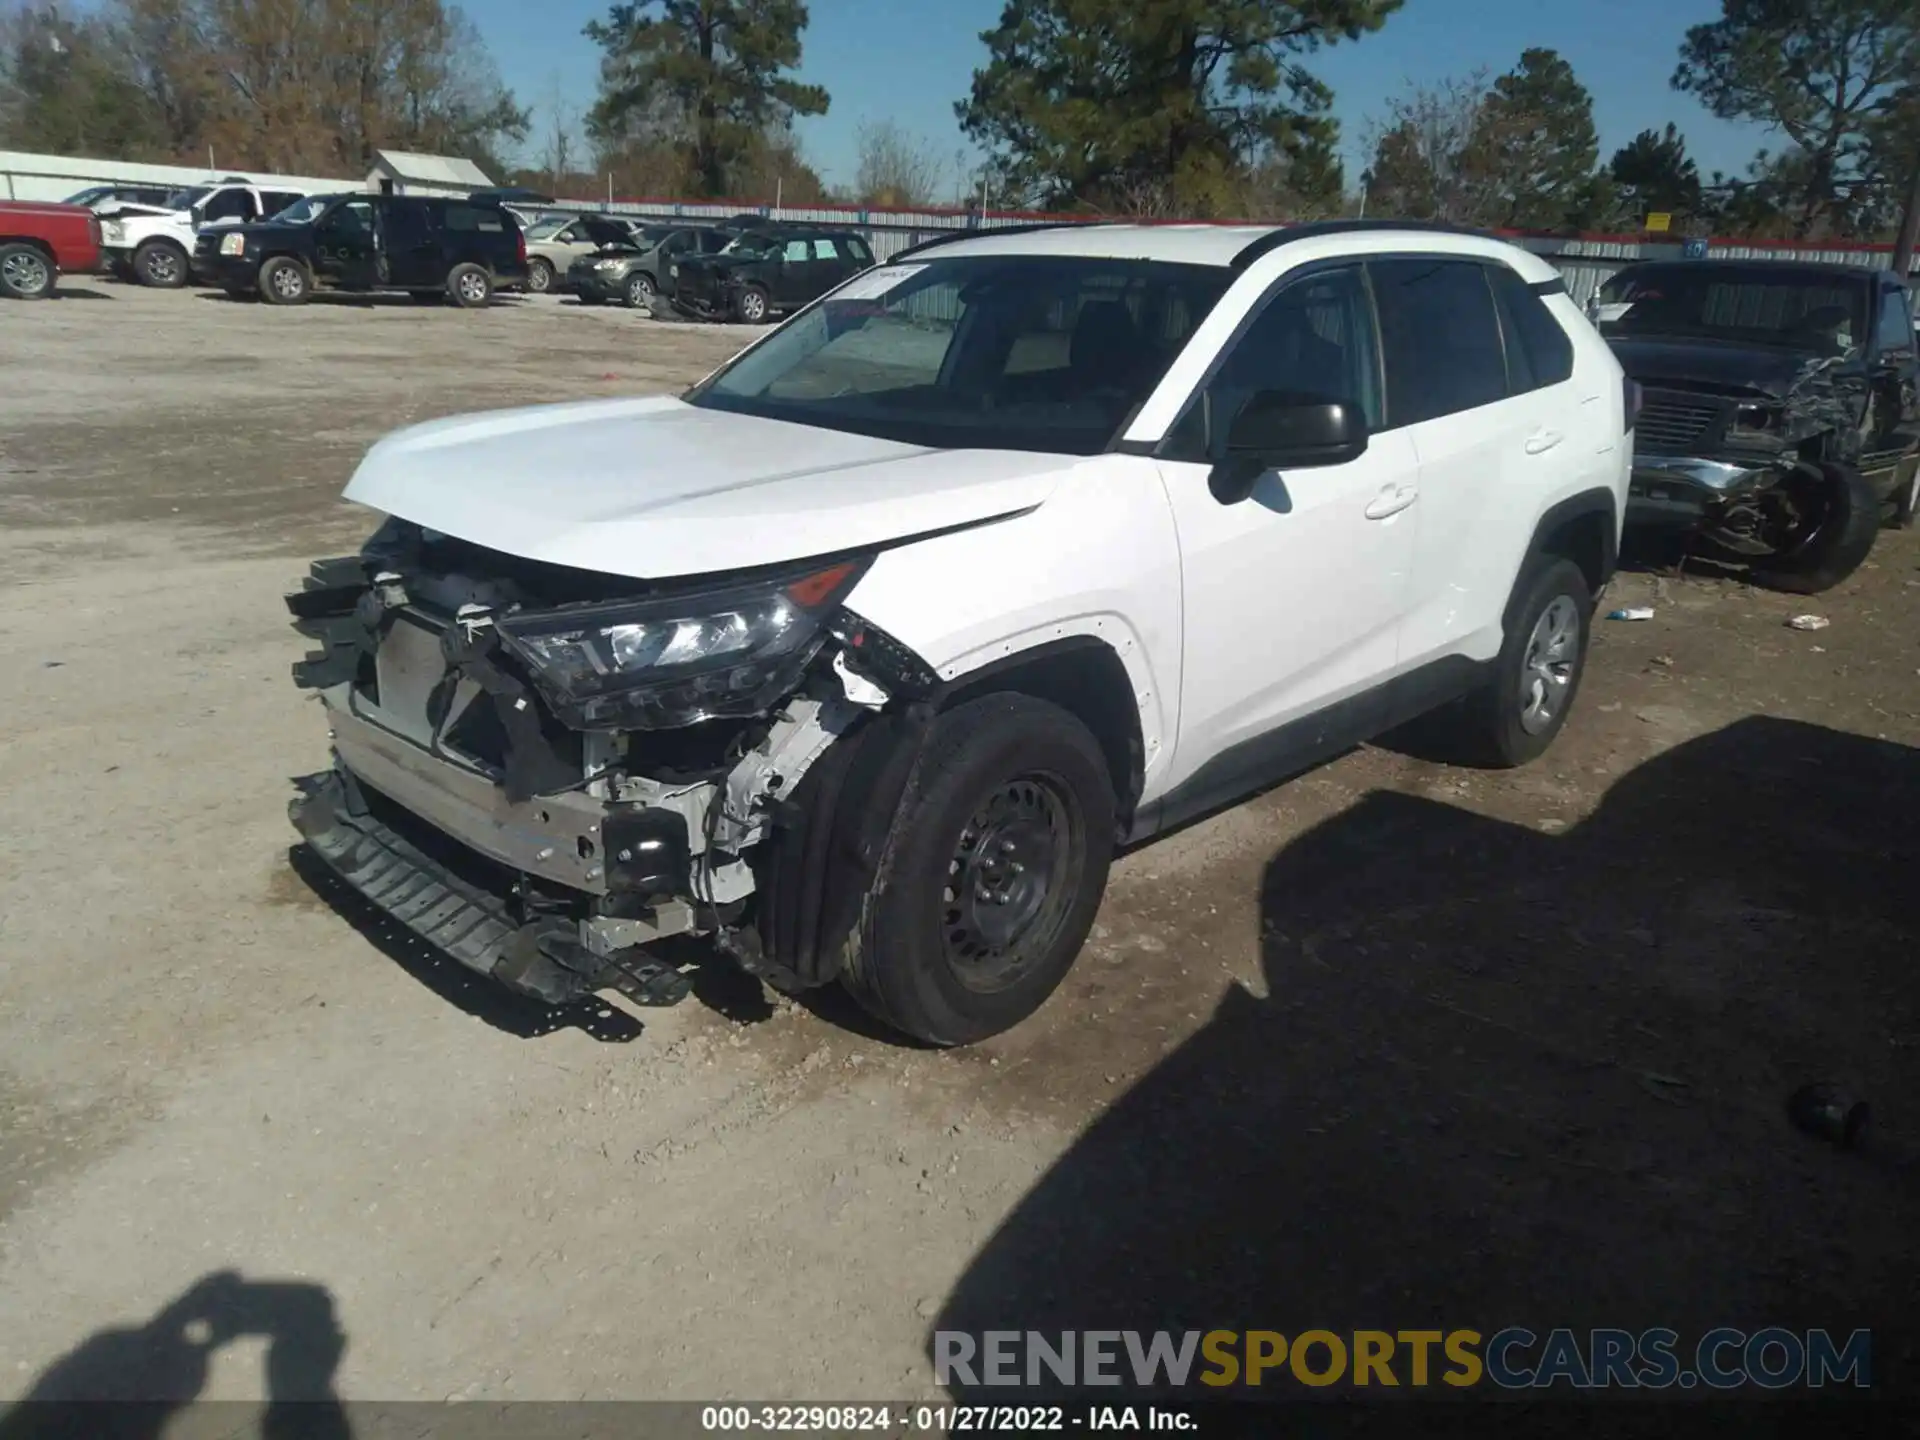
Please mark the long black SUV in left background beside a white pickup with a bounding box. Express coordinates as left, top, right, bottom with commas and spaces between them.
194, 194, 526, 309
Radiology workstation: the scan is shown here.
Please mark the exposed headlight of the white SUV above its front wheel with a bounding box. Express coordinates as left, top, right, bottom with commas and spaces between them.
497, 561, 866, 730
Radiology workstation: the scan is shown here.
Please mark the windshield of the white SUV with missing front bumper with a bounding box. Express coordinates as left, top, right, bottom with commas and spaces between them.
689, 255, 1233, 455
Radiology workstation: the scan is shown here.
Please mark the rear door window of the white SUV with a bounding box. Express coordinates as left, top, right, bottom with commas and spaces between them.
1369, 255, 1507, 428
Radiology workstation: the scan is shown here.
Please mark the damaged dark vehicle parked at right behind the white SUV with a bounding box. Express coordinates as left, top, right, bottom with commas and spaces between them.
1596, 259, 1920, 593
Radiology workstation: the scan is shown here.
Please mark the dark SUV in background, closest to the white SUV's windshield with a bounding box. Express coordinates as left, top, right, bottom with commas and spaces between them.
668, 225, 874, 324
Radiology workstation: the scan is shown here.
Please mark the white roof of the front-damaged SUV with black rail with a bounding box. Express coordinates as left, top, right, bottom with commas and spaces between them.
895, 221, 1553, 276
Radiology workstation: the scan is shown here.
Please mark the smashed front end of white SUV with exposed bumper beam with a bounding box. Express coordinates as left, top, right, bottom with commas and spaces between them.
288, 520, 935, 1004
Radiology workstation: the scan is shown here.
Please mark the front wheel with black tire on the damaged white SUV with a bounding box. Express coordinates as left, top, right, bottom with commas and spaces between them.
841, 695, 1114, 1044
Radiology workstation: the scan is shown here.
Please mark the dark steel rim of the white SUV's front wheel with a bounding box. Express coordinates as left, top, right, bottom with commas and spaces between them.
941, 774, 1079, 991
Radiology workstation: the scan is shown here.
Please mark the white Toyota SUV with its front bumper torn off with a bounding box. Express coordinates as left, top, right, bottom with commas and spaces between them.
288, 223, 1632, 1044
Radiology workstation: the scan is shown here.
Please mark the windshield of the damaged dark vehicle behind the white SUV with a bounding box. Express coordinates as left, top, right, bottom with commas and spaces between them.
1599, 265, 1866, 355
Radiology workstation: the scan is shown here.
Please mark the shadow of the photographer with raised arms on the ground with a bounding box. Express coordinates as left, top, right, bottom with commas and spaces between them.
0, 1271, 351, 1440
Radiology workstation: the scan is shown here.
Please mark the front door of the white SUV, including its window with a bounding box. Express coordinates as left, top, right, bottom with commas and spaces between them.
1162, 265, 1419, 789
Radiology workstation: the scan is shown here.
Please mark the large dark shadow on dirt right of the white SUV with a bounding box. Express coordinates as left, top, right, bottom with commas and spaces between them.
927, 718, 1920, 1400
